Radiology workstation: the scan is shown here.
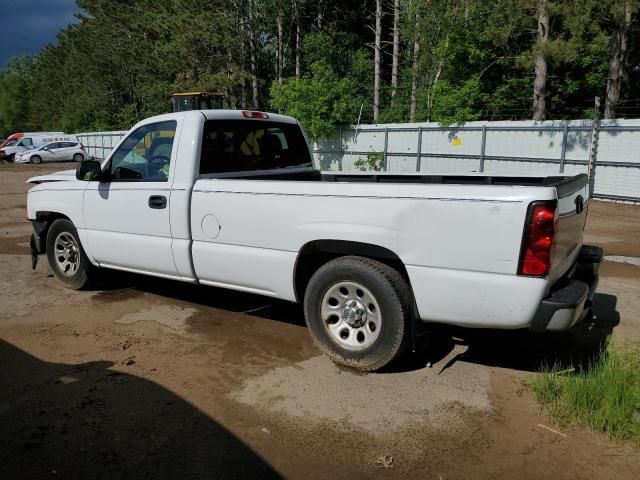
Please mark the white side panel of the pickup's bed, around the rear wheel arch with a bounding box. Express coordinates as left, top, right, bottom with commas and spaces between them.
191, 180, 554, 325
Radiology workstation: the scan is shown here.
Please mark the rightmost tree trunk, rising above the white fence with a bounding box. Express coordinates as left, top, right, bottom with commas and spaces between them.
604, 2, 633, 119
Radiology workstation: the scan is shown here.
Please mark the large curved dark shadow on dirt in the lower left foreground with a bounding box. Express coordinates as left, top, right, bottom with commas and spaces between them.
0, 340, 279, 479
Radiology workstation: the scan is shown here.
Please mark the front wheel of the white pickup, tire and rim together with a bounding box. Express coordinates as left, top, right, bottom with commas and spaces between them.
47, 219, 97, 290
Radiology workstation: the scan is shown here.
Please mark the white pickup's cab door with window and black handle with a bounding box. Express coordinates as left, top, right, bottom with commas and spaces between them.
84, 120, 177, 276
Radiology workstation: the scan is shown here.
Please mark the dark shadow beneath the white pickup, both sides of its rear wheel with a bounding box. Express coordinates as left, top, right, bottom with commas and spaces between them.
90, 273, 620, 374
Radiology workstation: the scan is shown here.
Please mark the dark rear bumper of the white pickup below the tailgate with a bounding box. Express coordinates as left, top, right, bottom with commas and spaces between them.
530, 245, 603, 332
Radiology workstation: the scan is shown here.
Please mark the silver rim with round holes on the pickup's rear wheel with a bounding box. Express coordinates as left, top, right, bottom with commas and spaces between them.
320, 281, 382, 350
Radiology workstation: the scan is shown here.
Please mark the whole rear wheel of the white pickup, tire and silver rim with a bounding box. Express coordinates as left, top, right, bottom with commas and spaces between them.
304, 256, 411, 371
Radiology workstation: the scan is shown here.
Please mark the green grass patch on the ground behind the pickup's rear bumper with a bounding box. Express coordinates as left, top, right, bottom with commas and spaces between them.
532, 342, 640, 446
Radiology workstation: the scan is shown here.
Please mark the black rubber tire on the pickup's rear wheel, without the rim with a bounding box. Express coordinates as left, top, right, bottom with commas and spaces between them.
304, 256, 412, 371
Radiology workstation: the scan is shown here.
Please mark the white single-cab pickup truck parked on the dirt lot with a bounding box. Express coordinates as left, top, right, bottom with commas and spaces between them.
27, 110, 602, 371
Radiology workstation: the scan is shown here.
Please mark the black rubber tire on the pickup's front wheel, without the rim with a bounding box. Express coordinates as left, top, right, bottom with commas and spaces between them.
47, 218, 98, 290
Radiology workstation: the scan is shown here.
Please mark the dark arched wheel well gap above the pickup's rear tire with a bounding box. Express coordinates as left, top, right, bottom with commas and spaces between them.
293, 240, 411, 302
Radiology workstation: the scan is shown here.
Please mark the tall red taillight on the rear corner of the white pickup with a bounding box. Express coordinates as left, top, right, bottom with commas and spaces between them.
518, 202, 556, 277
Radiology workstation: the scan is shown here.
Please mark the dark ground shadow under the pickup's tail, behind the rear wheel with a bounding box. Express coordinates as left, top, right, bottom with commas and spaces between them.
396, 293, 620, 374
